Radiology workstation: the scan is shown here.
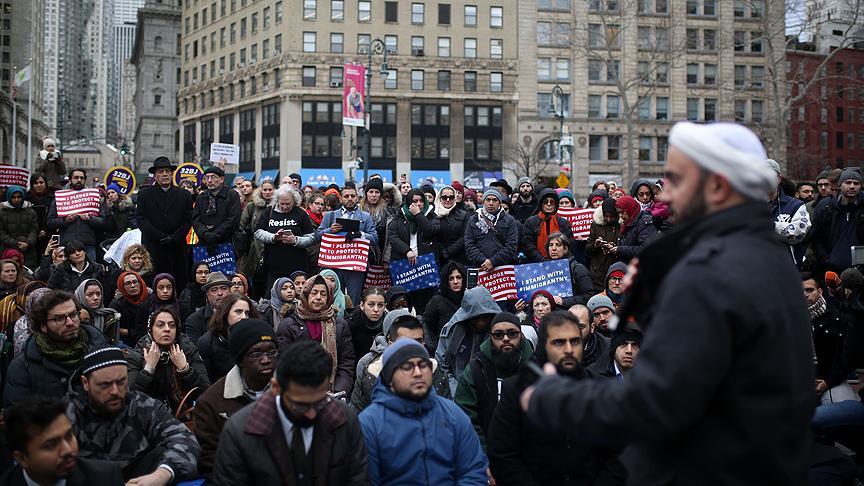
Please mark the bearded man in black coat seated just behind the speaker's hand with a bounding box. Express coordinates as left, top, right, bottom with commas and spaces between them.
489, 311, 625, 486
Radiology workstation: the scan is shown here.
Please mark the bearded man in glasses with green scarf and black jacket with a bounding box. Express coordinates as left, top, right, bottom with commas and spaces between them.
3, 290, 106, 406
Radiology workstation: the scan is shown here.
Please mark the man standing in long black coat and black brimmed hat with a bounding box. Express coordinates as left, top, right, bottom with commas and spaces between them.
137, 157, 192, 289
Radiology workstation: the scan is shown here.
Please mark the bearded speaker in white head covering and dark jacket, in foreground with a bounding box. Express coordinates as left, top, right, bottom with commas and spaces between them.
522, 122, 814, 485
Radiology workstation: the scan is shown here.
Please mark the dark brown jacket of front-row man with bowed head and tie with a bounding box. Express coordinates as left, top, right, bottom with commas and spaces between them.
213, 393, 368, 486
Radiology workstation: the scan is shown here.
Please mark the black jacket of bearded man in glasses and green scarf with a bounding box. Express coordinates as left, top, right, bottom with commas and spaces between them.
3, 324, 107, 407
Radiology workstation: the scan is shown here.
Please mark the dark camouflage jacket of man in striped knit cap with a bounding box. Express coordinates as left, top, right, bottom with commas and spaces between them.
66, 382, 201, 481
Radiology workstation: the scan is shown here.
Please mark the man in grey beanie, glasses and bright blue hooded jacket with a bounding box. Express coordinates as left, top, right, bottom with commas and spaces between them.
360, 338, 487, 485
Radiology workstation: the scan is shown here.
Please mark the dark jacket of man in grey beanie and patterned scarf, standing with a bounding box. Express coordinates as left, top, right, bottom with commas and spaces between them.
465, 210, 520, 267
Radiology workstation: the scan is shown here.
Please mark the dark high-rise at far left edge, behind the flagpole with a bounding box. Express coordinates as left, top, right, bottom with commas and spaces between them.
0, 0, 48, 164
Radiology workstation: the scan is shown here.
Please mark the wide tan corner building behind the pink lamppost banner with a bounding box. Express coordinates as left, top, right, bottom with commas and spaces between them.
178, 0, 523, 184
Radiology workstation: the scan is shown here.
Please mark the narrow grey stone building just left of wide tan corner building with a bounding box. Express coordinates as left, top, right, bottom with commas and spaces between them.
130, 0, 180, 171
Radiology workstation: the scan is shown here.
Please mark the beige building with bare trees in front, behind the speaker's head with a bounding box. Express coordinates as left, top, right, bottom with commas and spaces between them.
519, 0, 784, 196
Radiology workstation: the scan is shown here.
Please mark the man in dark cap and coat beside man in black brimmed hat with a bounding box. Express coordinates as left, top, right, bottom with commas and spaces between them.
192, 166, 240, 255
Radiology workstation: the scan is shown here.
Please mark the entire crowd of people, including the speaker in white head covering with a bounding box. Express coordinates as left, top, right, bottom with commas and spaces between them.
0, 123, 864, 486
